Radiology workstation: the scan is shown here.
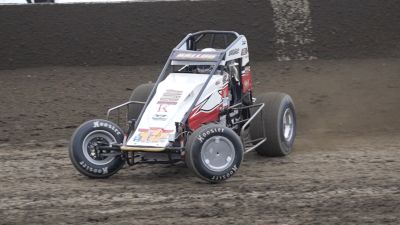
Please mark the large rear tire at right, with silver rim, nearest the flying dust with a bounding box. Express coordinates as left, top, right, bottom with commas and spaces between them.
250, 92, 296, 156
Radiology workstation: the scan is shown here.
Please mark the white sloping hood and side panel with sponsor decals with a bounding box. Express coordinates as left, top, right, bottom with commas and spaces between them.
127, 73, 223, 147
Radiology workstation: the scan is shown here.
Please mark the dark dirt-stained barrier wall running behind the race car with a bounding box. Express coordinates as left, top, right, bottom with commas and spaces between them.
0, 0, 400, 69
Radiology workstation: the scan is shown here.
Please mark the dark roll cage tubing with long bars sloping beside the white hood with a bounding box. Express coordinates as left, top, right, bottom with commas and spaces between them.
133, 30, 243, 135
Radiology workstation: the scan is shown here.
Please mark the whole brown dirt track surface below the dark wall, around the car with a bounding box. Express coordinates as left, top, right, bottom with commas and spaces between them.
0, 59, 400, 224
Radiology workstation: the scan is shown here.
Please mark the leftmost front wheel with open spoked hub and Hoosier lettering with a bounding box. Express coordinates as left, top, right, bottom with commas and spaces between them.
69, 119, 125, 178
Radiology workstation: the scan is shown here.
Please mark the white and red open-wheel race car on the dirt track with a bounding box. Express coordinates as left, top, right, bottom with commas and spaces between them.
69, 30, 296, 183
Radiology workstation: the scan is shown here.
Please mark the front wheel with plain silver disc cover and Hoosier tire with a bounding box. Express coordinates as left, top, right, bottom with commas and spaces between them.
185, 124, 244, 183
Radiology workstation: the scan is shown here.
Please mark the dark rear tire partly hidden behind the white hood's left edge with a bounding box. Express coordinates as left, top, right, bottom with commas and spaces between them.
127, 83, 154, 121
